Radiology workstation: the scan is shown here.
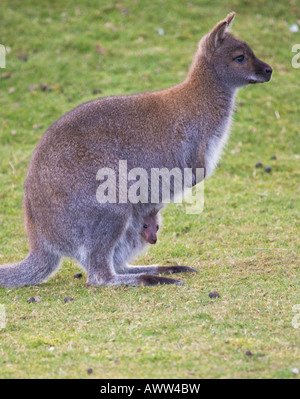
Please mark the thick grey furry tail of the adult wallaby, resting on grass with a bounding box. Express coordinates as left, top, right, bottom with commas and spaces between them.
0, 251, 60, 287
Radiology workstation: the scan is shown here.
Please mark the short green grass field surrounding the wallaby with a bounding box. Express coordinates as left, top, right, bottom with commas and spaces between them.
0, 0, 300, 378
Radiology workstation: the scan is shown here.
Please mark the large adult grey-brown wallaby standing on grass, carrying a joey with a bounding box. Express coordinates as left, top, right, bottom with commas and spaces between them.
0, 13, 272, 287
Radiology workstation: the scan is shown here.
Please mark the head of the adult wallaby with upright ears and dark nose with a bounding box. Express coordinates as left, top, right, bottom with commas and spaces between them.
199, 12, 272, 88
